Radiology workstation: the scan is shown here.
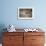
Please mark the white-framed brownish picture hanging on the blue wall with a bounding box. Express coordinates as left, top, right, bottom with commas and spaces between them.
18, 7, 34, 19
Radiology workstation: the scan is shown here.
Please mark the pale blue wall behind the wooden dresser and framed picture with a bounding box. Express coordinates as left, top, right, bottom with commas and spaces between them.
0, 0, 46, 29
